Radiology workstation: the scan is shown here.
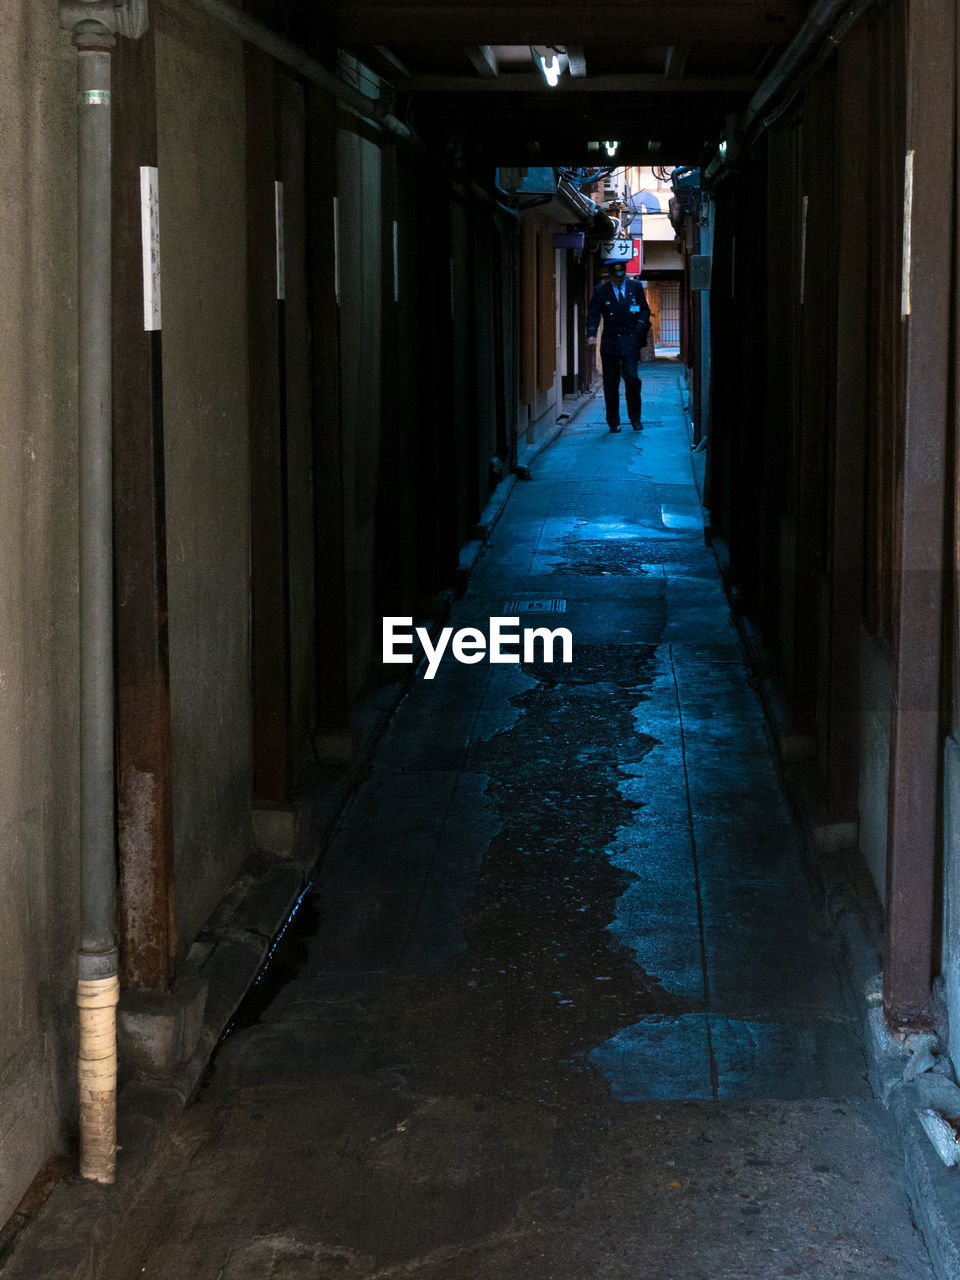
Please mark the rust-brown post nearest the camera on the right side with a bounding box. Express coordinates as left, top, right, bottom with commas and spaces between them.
883, 0, 956, 1024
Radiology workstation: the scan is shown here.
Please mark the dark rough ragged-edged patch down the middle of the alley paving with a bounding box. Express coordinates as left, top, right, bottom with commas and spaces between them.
363, 645, 689, 1106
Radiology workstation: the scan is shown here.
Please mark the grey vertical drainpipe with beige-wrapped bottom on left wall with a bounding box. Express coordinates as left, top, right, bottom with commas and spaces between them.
60, 0, 146, 1183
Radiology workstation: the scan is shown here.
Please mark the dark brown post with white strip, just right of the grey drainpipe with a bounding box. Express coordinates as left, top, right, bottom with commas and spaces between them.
113, 31, 177, 991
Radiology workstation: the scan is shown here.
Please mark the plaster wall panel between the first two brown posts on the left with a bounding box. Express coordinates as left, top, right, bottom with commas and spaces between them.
156, 3, 251, 948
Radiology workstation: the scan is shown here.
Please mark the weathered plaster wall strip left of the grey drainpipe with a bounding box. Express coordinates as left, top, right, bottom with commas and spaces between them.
0, 0, 79, 1221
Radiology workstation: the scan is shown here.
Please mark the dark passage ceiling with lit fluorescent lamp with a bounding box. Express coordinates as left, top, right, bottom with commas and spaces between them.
334, 0, 808, 165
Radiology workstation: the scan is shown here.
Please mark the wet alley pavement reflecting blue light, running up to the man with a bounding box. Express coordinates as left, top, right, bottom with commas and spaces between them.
5, 364, 931, 1280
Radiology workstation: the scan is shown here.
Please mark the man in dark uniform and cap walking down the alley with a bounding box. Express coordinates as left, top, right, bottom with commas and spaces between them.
586, 247, 650, 431
